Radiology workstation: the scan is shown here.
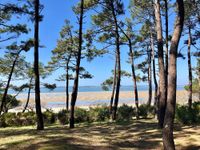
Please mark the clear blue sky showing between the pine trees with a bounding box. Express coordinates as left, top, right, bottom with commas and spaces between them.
1, 0, 196, 86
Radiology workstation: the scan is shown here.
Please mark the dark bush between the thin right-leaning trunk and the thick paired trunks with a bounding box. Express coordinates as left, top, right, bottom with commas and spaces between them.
138, 104, 155, 118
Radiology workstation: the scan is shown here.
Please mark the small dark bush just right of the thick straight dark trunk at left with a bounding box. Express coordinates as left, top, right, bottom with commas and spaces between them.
43, 109, 56, 124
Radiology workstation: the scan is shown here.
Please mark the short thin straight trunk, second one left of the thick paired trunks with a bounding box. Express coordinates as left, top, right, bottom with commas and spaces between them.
148, 47, 152, 106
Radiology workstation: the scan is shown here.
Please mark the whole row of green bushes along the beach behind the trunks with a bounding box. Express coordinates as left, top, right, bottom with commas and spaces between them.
0, 102, 200, 127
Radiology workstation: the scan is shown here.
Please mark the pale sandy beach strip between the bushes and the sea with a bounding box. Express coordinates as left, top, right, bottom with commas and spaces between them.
11, 90, 198, 111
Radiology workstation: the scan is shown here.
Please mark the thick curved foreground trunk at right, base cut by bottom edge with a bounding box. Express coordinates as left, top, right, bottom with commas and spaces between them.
163, 0, 184, 150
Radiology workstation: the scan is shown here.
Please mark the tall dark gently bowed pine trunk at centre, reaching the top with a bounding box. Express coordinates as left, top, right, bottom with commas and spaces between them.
110, 1, 121, 120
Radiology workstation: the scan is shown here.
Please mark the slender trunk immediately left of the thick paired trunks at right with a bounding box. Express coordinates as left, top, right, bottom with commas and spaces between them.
151, 31, 158, 113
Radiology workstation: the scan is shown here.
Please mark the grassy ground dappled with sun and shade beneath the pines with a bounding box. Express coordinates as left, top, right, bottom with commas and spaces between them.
0, 119, 200, 150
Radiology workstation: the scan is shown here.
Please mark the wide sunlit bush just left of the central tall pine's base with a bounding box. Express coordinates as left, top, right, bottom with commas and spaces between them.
89, 106, 110, 122
